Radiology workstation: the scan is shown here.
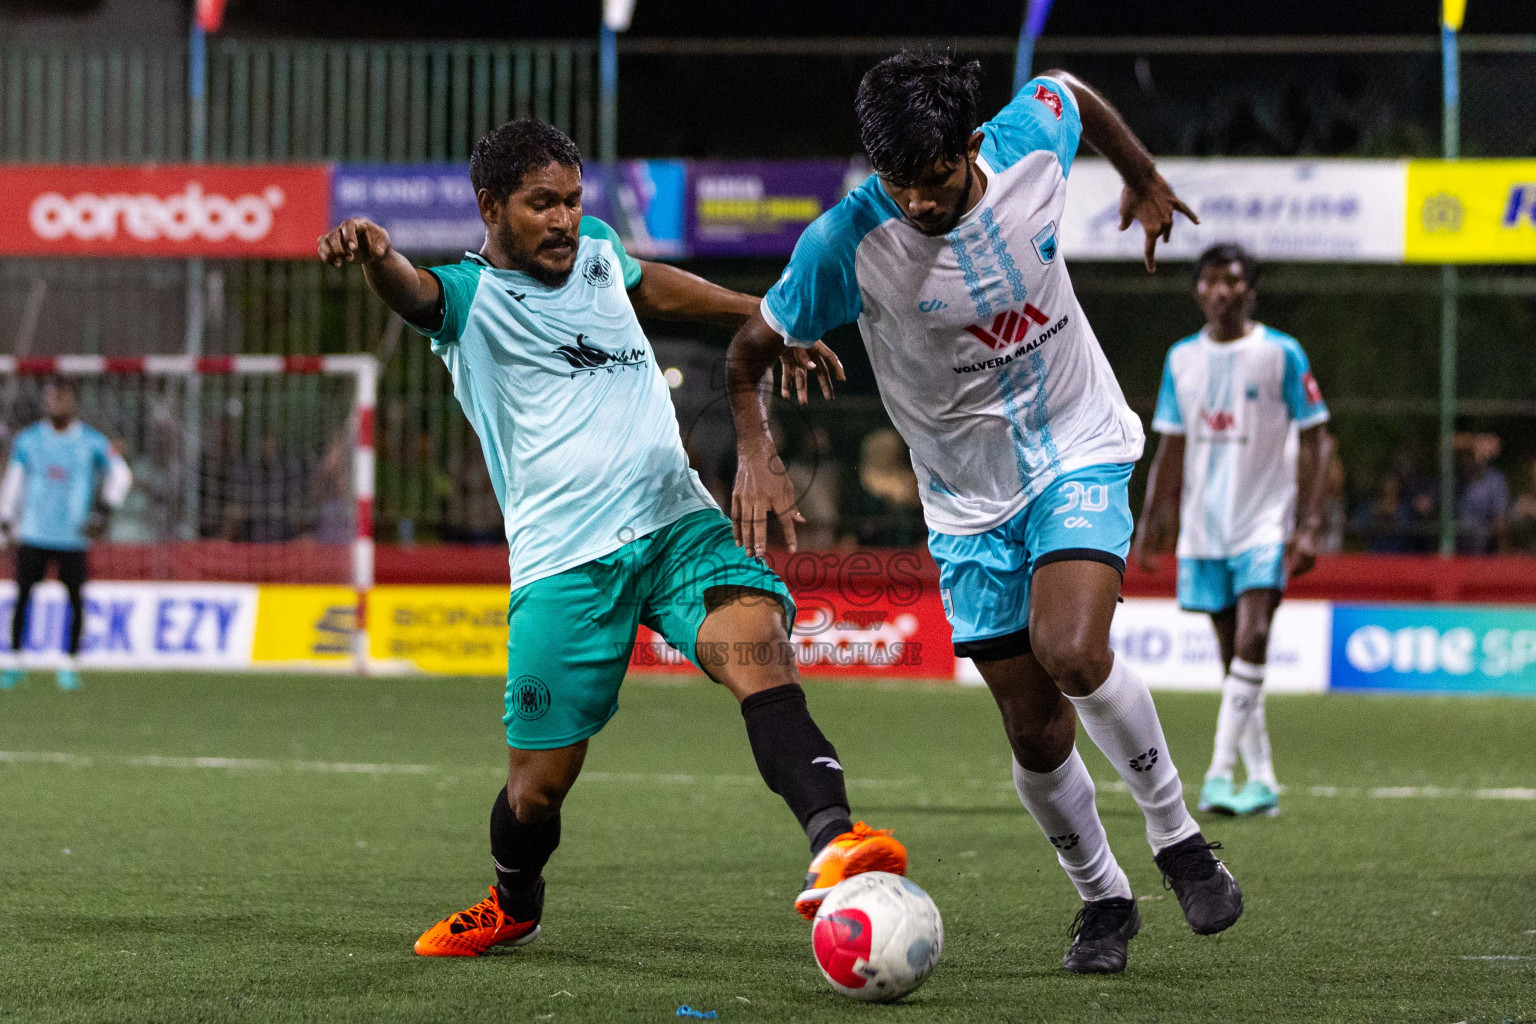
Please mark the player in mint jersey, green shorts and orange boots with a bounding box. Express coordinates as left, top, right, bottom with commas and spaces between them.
319, 121, 906, 956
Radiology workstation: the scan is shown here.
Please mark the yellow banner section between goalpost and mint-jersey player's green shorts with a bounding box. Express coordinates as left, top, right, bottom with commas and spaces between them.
369, 586, 507, 676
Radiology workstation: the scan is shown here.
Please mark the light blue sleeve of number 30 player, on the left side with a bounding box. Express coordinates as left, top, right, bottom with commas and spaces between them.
762, 200, 863, 348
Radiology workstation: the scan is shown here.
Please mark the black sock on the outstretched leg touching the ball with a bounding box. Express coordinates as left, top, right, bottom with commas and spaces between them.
742, 683, 852, 852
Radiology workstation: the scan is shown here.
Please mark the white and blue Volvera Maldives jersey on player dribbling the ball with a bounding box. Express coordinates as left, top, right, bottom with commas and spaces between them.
762, 78, 1143, 534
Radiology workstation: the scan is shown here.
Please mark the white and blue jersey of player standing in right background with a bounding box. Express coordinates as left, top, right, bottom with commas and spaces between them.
1152, 324, 1329, 559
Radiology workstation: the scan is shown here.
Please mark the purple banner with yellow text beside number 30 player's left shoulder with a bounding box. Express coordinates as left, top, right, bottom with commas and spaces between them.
688, 160, 868, 256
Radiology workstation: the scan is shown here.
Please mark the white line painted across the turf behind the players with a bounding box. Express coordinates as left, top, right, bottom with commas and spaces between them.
0, 751, 1536, 800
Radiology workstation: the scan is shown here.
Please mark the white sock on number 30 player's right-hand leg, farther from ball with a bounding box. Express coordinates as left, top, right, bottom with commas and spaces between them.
1068, 656, 1200, 854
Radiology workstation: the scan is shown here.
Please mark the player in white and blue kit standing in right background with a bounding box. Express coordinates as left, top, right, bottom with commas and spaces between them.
1137, 244, 1333, 814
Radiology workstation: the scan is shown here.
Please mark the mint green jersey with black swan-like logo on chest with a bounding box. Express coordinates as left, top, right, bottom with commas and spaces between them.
414, 216, 717, 590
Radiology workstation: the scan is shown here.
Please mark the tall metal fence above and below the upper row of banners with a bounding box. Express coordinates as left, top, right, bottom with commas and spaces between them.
0, 35, 1536, 552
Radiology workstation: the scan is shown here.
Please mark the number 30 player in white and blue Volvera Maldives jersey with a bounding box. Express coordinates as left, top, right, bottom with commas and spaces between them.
730, 52, 1243, 973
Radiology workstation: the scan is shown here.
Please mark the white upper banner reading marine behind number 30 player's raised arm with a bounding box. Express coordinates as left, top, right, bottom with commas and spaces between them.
1058, 158, 1407, 263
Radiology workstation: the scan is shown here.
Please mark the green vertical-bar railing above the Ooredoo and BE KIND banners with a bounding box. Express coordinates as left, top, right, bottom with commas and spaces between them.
0, 40, 598, 163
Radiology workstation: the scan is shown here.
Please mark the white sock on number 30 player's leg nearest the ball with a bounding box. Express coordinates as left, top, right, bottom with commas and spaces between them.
1014, 746, 1130, 900
